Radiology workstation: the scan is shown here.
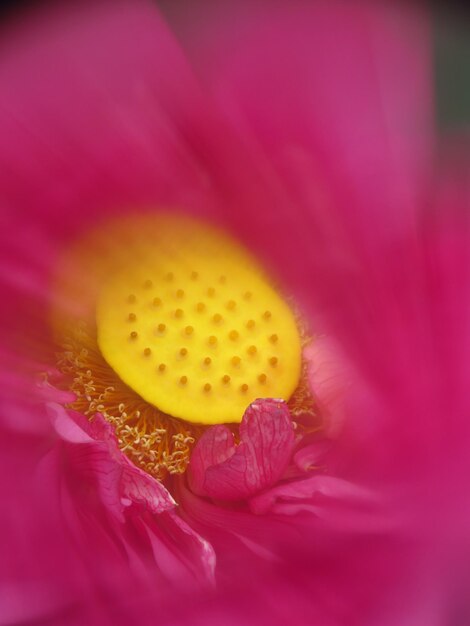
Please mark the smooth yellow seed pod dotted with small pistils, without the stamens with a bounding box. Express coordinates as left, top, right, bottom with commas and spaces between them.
96, 216, 301, 424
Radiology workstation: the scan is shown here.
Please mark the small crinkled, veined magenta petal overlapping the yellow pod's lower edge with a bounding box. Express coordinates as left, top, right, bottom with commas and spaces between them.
189, 399, 294, 500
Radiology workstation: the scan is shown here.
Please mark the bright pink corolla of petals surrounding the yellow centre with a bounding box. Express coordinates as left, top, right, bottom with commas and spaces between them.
0, 0, 469, 625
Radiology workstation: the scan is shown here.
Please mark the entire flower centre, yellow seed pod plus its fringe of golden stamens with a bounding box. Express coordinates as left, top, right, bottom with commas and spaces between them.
51, 214, 308, 479
